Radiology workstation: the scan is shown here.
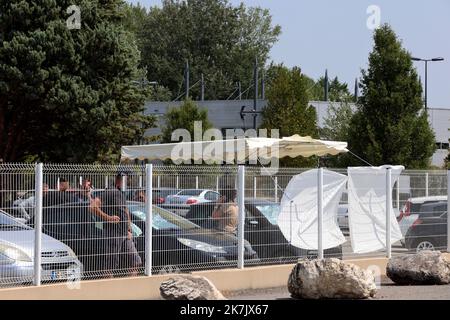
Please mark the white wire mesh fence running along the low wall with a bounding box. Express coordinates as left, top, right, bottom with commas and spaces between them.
0, 164, 450, 287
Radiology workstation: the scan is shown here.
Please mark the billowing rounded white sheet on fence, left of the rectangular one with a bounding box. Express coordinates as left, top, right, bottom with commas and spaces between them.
278, 169, 347, 250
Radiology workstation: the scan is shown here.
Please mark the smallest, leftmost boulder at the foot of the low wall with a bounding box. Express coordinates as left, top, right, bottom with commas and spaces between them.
159, 275, 225, 300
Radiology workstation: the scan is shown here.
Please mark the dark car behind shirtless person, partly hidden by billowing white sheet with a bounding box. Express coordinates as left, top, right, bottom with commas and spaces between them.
186, 198, 342, 262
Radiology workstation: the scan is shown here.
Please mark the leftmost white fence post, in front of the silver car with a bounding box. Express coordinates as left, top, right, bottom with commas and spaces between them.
33, 163, 43, 286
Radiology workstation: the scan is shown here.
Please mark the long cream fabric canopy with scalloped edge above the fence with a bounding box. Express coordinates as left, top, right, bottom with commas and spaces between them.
121, 135, 348, 163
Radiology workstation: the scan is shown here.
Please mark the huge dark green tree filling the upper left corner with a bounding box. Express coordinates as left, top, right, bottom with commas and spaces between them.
0, 0, 154, 162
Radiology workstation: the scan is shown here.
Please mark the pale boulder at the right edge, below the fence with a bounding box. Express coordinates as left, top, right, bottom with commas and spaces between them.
386, 250, 450, 285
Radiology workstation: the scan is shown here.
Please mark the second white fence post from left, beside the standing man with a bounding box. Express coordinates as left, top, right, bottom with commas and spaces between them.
145, 163, 153, 276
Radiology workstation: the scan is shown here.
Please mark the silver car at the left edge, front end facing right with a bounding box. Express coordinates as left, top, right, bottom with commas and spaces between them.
0, 210, 83, 285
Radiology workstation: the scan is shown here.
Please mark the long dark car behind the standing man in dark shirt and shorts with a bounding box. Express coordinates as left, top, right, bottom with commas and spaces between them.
43, 201, 258, 276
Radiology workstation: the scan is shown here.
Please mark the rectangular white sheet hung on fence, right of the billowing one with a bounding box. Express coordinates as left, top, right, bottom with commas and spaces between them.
348, 166, 405, 253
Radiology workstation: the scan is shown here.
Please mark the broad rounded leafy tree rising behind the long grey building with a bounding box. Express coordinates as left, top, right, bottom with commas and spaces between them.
138, 0, 280, 99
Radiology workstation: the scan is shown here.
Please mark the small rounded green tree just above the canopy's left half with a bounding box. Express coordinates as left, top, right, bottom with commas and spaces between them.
161, 100, 212, 143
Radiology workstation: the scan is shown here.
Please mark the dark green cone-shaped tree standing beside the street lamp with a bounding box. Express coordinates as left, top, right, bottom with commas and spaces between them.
348, 25, 435, 169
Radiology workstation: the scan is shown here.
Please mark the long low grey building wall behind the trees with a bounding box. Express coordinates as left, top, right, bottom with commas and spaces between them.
145, 100, 450, 167
